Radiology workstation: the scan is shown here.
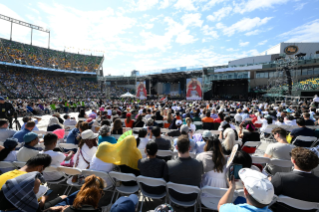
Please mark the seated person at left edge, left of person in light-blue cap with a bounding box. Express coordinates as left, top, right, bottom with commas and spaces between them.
0, 138, 19, 173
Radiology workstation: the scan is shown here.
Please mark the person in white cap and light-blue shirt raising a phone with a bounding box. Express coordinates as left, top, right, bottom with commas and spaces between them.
217, 168, 274, 212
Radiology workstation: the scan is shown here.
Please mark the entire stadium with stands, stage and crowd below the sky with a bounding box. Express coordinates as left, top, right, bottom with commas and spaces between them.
0, 4, 319, 212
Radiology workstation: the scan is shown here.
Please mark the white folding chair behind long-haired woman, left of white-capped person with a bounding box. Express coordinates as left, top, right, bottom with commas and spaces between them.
200, 186, 238, 211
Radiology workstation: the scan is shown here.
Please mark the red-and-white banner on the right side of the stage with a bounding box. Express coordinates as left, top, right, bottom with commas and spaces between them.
186, 78, 203, 100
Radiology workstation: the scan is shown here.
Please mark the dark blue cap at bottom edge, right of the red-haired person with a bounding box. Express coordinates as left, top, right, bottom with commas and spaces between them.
110, 194, 138, 212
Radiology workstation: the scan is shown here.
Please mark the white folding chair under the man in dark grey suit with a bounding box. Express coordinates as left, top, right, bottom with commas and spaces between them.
166, 182, 201, 212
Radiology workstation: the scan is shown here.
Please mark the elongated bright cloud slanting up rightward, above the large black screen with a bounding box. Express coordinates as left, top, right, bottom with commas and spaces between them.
220, 17, 272, 37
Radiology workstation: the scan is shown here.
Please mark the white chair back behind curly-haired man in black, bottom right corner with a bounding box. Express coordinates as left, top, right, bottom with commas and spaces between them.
276, 195, 319, 211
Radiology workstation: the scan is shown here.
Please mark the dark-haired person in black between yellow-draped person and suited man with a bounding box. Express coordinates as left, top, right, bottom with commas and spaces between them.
138, 142, 167, 194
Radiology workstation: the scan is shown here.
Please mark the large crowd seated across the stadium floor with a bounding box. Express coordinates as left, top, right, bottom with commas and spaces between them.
0, 96, 319, 212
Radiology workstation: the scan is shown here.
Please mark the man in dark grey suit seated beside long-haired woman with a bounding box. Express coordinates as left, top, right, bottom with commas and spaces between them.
167, 136, 203, 201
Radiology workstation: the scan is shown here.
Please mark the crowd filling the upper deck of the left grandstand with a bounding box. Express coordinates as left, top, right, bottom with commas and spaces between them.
0, 39, 102, 72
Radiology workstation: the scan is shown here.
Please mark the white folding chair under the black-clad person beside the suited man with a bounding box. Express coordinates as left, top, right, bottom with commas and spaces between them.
136, 175, 167, 212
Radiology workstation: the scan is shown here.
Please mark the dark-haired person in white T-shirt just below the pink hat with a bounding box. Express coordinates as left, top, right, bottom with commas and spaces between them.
40, 133, 74, 181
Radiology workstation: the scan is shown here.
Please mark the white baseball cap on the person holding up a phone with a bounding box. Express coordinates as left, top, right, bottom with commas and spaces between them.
238, 168, 275, 205
